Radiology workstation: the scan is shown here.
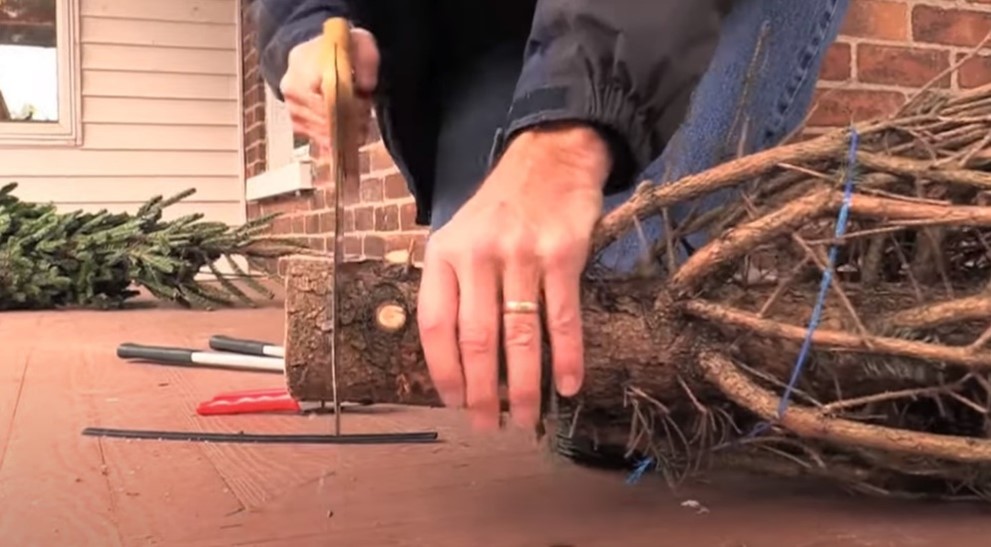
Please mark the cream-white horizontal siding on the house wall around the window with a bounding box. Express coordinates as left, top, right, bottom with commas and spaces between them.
0, 0, 245, 227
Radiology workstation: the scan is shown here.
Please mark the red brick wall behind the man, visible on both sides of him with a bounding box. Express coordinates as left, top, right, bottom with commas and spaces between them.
244, 0, 991, 258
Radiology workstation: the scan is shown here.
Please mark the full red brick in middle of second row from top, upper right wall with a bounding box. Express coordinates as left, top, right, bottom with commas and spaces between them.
857, 44, 950, 87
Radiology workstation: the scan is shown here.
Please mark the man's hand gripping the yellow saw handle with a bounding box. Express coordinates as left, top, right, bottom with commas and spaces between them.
279, 29, 380, 153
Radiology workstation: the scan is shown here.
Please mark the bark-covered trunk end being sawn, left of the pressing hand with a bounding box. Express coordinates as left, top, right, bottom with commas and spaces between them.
285, 256, 440, 406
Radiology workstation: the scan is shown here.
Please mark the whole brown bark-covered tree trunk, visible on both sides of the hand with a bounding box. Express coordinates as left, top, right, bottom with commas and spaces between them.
286, 256, 932, 415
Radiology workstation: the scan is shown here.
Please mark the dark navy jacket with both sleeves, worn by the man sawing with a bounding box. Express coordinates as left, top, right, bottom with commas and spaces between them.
255, 0, 733, 224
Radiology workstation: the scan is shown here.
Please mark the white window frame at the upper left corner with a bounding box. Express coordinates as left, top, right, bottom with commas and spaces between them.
0, 0, 82, 146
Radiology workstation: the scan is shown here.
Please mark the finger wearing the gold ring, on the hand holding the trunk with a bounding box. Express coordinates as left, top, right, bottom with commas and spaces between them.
502, 246, 541, 427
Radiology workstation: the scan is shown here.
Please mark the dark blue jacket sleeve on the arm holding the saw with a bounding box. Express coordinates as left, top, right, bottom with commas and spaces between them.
255, 0, 351, 101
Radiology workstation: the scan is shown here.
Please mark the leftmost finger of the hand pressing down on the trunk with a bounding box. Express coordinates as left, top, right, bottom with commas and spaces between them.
417, 244, 465, 408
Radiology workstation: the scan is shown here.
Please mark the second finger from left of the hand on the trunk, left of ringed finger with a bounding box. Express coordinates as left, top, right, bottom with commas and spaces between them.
457, 251, 499, 429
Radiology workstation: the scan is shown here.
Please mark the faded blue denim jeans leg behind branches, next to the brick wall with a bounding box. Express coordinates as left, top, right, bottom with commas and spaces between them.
598, 0, 850, 271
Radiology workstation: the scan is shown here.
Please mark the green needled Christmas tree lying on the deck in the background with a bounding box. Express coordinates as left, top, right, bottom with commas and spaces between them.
0, 183, 303, 310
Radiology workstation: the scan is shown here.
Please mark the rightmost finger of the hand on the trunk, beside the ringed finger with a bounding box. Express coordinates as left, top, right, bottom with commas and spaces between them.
543, 246, 585, 397
